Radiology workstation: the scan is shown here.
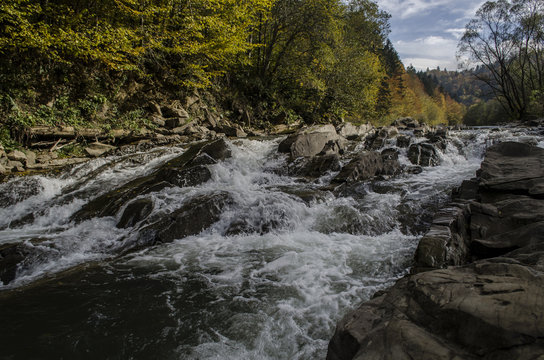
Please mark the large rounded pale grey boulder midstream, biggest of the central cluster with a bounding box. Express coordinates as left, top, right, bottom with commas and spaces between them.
278, 124, 345, 159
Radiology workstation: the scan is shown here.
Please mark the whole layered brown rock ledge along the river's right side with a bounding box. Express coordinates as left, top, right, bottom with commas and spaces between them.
327, 142, 544, 360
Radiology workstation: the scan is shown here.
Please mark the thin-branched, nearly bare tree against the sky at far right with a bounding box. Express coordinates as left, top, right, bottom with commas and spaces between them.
459, 0, 544, 119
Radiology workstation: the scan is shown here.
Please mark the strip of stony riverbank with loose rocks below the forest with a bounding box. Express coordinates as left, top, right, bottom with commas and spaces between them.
0, 114, 432, 180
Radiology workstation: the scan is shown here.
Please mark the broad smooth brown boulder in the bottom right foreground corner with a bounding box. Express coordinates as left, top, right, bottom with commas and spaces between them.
327, 246, 544, 360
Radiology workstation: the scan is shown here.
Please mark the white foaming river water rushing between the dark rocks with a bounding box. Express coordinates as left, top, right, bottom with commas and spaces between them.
0, 129, 544, 359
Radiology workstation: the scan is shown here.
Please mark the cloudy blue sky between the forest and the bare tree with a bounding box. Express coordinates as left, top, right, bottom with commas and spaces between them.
376, 0, 485, 70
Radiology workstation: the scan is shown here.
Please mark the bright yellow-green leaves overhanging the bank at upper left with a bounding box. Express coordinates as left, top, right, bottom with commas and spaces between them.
0, 0, 272, 84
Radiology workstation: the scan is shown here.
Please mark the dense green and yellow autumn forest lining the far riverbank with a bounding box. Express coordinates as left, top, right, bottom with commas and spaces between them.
0, 0, 464, 149
